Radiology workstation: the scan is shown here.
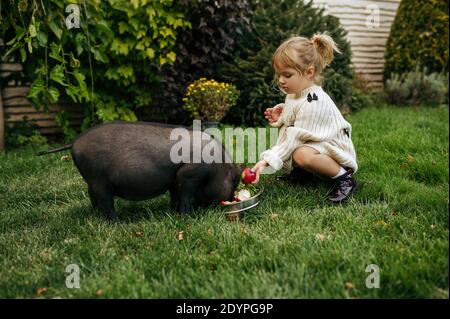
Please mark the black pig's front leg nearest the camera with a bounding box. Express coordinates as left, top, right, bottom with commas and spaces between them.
170, 164, 209, 214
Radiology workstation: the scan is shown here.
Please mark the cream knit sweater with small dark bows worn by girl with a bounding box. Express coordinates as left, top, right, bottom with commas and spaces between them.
260, 85, 358, 172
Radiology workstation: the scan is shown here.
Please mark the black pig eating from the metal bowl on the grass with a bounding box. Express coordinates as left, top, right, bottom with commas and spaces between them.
39, 122, 241, 221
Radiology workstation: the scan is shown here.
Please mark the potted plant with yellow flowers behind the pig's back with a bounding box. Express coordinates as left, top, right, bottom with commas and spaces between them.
183, 78, 239, 130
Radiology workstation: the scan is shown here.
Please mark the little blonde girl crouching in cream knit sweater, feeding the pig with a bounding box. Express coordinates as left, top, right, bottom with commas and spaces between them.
252, 34, 358, 203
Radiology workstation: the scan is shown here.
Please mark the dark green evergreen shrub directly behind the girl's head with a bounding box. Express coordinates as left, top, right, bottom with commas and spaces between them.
220, 0, 353, 125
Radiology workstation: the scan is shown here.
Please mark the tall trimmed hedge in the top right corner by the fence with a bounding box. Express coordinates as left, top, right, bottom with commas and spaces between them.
384, 0, 449, 80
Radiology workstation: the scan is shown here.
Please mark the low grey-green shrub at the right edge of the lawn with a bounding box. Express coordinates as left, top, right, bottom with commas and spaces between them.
384, 67, 448, 105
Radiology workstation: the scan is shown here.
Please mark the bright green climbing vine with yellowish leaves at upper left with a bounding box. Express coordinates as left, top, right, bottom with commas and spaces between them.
0, 0, 190, 135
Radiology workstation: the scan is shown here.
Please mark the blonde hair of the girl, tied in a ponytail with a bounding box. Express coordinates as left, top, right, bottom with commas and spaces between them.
272, 33, 341, 85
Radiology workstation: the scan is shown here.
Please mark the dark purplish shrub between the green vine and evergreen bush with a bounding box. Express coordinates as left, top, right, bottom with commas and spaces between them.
147, 0, 255, 123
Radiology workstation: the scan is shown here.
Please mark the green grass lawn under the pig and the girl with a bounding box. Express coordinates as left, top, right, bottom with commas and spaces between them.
0, 107, 449, 298
